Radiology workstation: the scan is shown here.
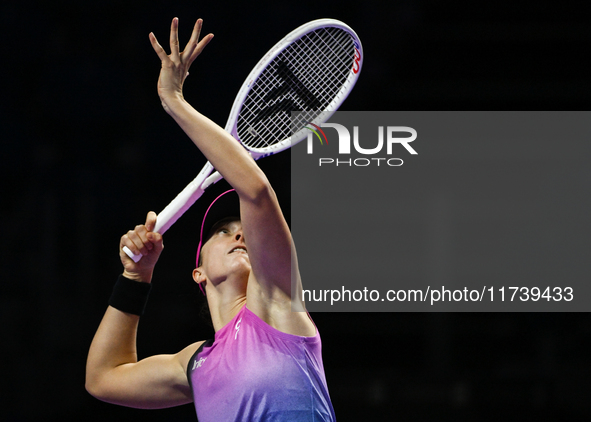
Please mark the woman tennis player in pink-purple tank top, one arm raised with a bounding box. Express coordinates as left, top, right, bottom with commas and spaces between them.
86, 18, 335, 422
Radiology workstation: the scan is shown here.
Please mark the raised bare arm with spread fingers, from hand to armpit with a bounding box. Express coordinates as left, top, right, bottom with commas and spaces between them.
150, 18, 315, 335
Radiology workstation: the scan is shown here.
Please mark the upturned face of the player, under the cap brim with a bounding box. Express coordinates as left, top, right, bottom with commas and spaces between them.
201, 221, 250, 283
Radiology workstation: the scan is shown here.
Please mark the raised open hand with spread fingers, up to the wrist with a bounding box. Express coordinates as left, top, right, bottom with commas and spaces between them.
150, 18, 213, 111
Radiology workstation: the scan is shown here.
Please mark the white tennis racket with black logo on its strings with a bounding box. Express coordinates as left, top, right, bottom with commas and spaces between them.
123, 19, 363, 262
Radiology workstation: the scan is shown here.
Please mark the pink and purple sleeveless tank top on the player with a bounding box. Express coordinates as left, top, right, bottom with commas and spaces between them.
187, 306, 335, 422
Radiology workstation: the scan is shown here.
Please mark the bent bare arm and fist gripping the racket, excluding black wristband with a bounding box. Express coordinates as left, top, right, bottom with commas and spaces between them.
86, 212, 203, 409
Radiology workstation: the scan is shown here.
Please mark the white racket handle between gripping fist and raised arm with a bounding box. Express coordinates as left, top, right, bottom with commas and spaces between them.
122, 162, 215, 263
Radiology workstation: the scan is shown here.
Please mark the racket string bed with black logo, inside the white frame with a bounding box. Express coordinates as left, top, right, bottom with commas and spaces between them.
237, 27, 355, 148
